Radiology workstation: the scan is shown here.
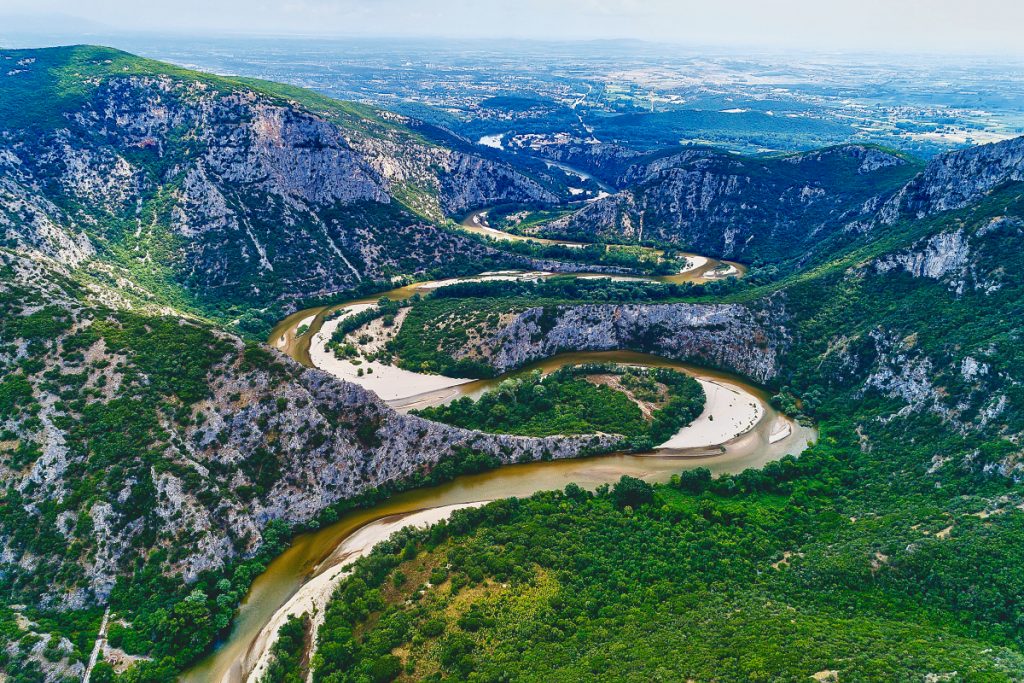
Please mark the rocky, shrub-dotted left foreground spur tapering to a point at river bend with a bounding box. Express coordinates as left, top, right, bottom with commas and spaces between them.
0, 250, 614, 608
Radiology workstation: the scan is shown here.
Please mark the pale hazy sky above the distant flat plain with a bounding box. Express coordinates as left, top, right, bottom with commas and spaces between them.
0, 0, 1024, 55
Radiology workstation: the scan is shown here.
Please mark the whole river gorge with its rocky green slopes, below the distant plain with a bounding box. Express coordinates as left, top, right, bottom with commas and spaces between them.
0, 41, 1024, 683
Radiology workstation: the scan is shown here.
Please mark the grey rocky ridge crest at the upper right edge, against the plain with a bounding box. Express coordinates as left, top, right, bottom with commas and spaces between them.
879, 137, 1024, 224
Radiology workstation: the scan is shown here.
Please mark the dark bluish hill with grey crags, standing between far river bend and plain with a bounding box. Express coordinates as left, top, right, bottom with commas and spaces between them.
548, 145, 912, 261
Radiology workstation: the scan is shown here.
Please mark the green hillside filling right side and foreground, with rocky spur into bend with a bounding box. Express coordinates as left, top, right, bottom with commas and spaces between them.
292, 142, 1024, 681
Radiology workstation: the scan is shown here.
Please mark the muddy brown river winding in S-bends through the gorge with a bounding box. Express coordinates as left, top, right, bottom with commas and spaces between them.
188, 242, 802, 683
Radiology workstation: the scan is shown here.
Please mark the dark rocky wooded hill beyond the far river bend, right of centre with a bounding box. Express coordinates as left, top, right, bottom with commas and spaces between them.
537, 143, 922, 269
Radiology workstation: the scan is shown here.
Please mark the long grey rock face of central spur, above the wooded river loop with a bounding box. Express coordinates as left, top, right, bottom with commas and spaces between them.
444, 298, 792, 382
